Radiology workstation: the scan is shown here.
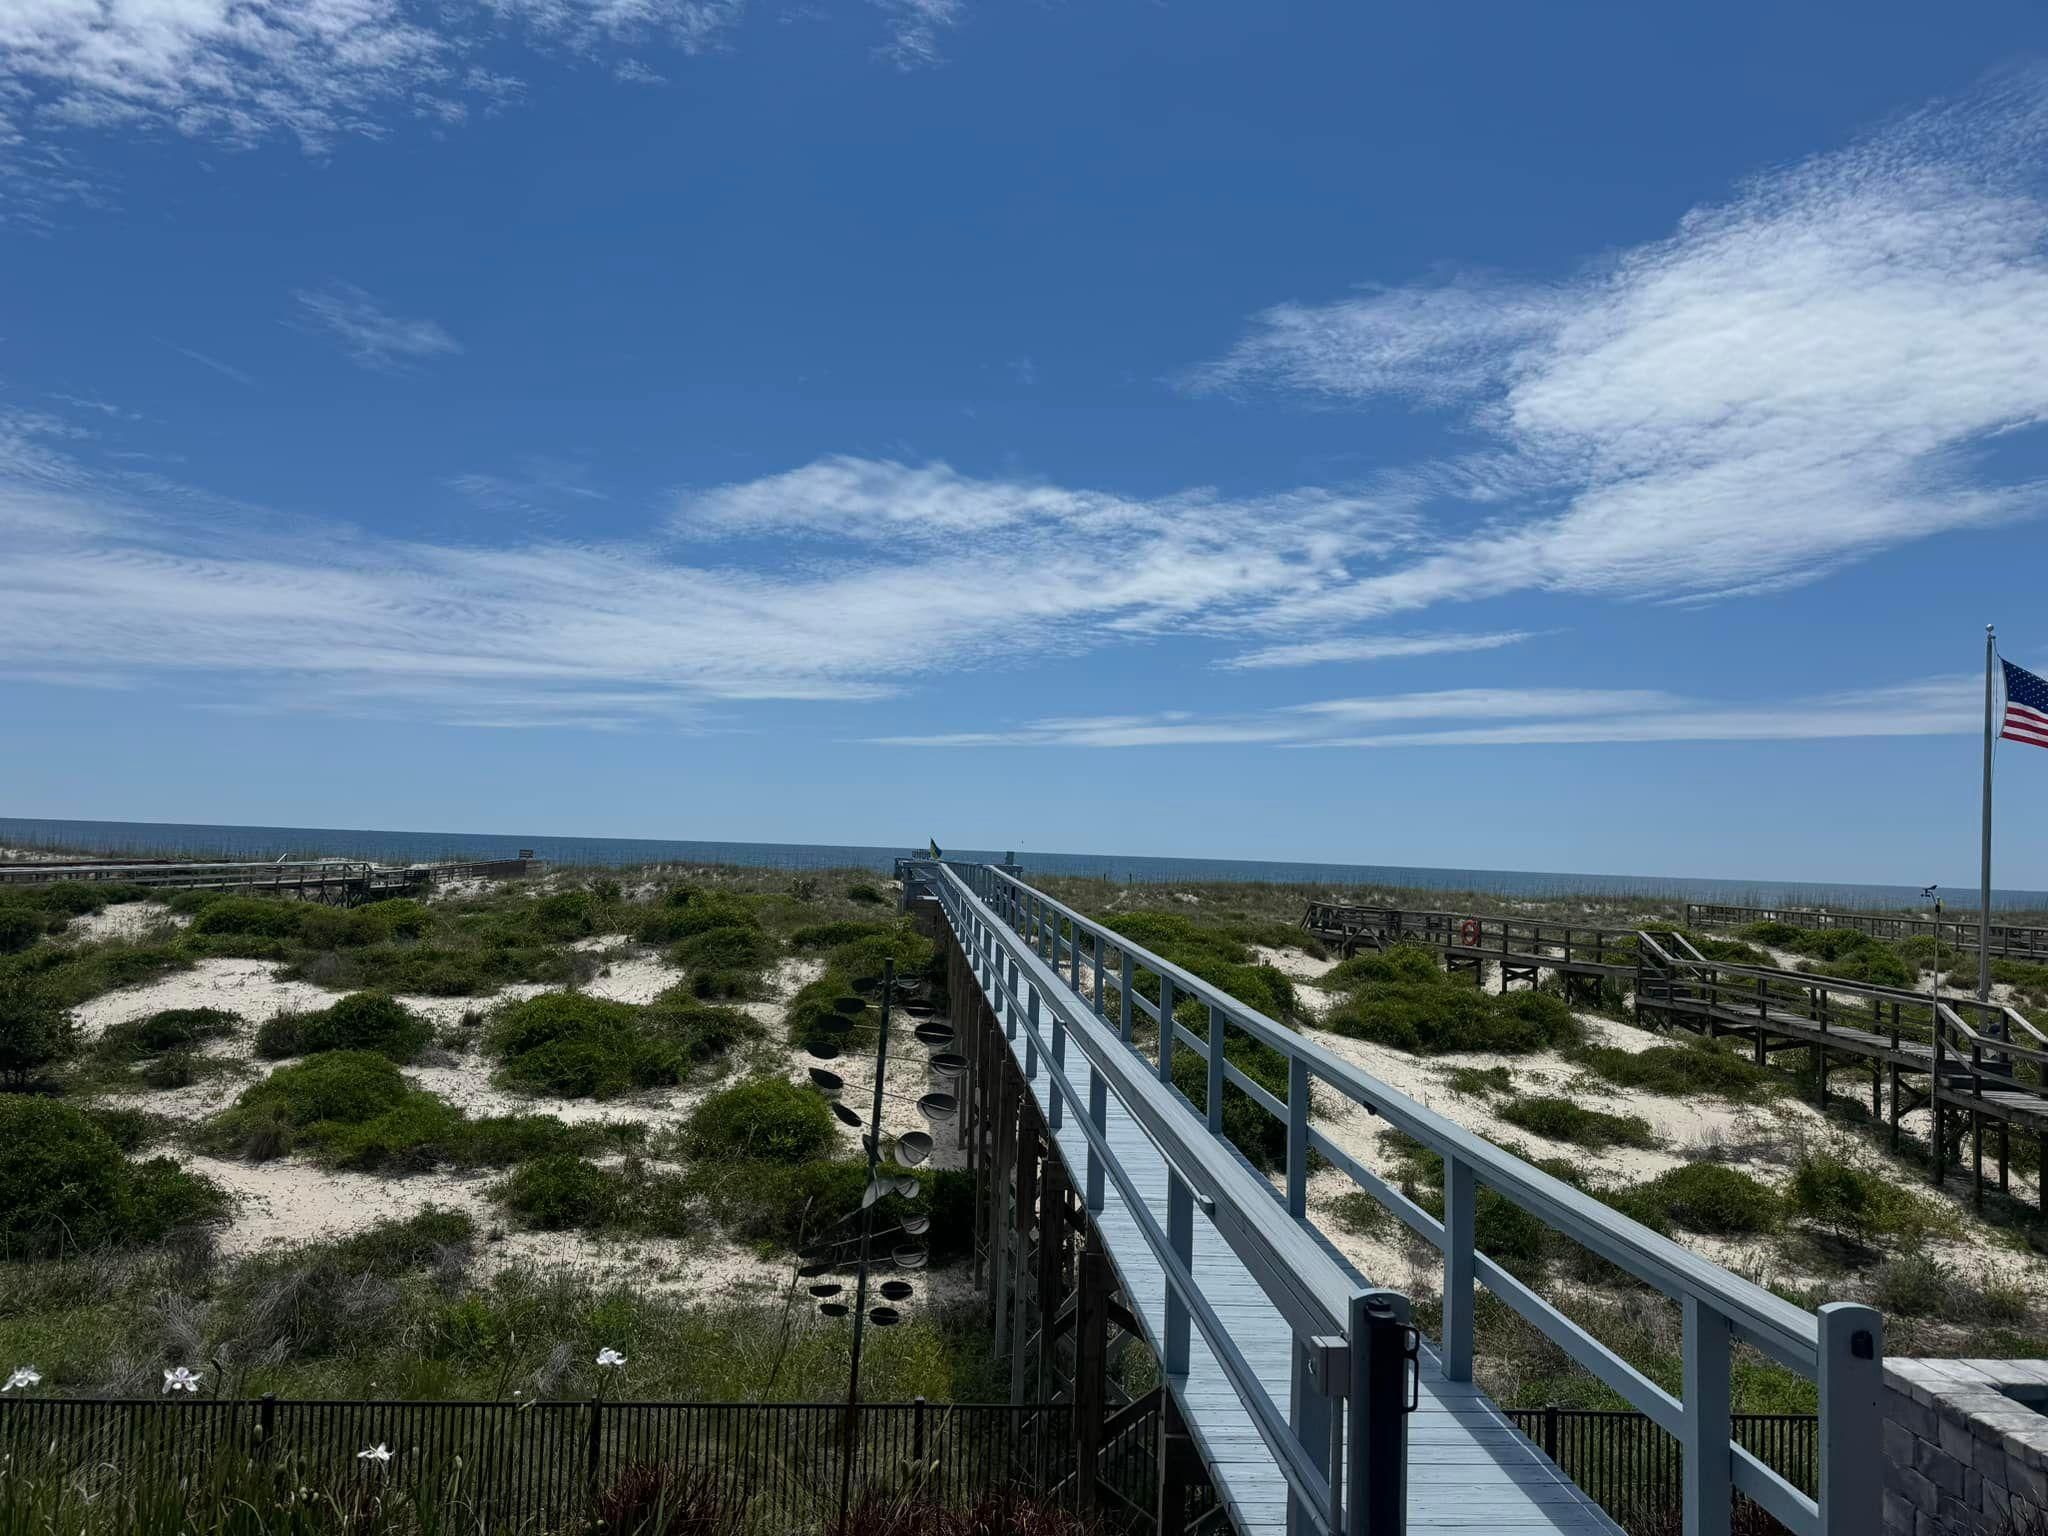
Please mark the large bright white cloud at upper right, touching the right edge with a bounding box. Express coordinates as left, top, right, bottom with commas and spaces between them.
1188, 72, 2048, 625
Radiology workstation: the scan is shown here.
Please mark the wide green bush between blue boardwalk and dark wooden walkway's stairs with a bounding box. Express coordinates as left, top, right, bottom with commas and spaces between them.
1323, 944, 1585, 1055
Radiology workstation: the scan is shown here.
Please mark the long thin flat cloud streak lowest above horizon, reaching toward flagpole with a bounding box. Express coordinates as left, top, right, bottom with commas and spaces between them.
872, 678, 1980, 748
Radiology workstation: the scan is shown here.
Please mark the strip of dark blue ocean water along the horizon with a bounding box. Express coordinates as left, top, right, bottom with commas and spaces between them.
0, 817, 2048, 909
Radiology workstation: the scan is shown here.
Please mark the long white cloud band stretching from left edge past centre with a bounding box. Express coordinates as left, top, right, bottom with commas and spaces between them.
0, 448, 1407, 729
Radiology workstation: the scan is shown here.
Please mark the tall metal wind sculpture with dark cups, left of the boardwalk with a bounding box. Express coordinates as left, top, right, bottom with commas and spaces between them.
797, 961, 967, 1522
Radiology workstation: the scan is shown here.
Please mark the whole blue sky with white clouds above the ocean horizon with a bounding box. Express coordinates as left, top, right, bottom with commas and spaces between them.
0, 0, 2048, 887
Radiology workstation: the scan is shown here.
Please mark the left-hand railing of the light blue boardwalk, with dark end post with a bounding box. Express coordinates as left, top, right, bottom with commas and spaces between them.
920, 864, 1407, 1536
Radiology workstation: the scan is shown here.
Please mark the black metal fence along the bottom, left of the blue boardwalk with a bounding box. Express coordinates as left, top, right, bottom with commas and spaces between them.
0, 1397, 1105, 1530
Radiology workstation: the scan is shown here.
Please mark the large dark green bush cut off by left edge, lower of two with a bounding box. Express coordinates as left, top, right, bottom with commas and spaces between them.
0, 1096, 227, 1257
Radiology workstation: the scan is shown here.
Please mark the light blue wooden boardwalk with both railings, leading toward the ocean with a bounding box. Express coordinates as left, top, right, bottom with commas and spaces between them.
929, 860, 1882, 1536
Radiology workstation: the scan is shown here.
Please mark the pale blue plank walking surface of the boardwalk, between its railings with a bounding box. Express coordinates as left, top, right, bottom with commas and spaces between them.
974, 937, 1620, 1536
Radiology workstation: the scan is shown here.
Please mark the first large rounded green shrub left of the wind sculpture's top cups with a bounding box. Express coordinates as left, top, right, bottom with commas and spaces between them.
485, 991, 688, 1098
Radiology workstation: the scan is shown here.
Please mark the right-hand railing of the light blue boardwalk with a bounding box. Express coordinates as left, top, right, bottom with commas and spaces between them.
938, 864, 1882, 1536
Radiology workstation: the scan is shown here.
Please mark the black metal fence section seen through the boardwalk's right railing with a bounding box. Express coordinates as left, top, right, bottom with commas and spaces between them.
1507, 1407, 1821, 1532
